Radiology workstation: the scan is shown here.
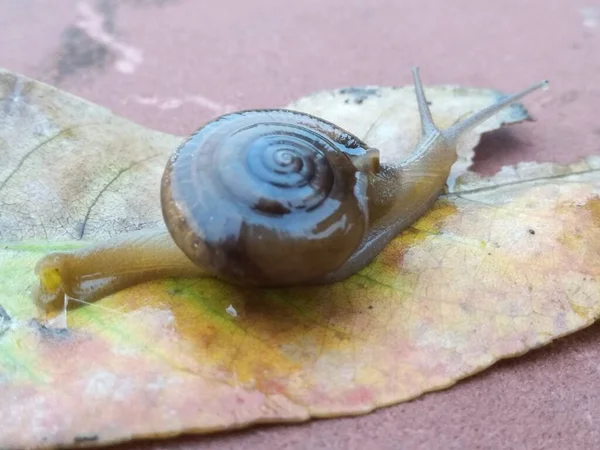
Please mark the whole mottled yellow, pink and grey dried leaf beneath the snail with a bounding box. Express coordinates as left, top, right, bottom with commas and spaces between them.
0, 67, 600, 448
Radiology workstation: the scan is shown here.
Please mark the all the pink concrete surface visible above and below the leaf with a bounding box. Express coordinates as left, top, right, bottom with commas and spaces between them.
0, 0, 600, 450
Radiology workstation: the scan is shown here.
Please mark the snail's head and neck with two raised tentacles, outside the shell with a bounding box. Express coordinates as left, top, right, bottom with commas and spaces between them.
322, 67, 548, 282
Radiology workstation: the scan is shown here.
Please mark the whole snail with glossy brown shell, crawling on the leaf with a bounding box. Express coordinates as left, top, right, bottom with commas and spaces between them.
35, 67, 547, 312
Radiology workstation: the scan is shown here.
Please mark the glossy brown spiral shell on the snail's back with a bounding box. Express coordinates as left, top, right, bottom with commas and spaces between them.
161, 110, 378, 285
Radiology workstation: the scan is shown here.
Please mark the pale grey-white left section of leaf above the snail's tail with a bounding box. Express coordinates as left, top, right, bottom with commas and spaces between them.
0, 70, 181, 242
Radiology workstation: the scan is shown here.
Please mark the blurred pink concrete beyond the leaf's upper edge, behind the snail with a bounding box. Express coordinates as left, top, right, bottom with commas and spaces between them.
0, 0, 600, 173
